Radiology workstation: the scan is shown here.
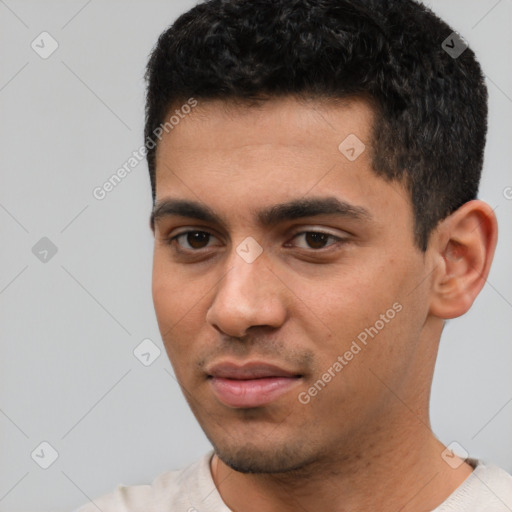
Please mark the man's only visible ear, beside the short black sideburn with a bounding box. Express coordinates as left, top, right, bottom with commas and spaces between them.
429, 200, 498, 319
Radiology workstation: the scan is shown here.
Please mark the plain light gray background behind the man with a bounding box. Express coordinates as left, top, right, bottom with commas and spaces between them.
0, 0, 512, 512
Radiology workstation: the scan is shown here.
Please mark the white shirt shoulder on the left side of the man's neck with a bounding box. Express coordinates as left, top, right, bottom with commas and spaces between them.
73, 452, 216, 512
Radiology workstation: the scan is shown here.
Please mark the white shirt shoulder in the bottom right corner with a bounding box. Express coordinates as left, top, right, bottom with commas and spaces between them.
434, 460, 512, 512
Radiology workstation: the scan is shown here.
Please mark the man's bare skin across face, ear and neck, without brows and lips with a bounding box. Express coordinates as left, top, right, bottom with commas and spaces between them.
153, 97, 497, 512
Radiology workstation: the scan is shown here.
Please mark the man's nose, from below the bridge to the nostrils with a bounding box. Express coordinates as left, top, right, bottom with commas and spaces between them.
206, 251, 287, 337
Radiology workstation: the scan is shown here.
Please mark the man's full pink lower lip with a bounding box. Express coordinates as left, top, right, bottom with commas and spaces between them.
210, 377, 300, 407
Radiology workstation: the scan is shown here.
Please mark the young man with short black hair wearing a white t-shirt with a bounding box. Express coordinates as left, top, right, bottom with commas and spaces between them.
74, 0, 512, 512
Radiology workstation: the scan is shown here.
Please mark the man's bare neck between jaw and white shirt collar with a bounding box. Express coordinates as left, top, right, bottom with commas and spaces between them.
211, 409, 473, 512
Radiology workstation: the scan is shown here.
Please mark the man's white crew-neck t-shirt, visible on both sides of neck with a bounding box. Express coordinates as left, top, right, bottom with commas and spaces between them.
74, 450, 512, 512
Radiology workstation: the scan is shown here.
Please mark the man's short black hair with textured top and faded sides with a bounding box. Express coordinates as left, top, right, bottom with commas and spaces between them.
144, 0, 487, 251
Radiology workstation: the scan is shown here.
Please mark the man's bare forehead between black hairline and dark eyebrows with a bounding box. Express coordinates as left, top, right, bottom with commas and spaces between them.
152, 98, 407, 233
